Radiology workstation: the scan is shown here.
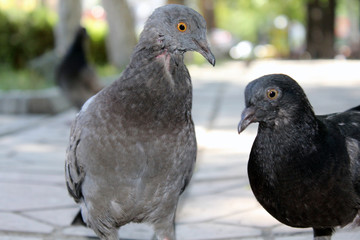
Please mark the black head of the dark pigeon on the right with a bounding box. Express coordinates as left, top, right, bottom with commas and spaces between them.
238, 74, 314, 133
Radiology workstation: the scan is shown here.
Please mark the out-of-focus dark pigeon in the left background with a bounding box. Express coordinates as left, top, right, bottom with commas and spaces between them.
55, 27, 103, 109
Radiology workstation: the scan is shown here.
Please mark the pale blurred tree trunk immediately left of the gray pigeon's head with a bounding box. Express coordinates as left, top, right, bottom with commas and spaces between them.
103, 0, 137, 68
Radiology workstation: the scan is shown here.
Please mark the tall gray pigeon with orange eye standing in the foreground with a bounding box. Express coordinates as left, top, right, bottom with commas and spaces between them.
65, 5, 215, 240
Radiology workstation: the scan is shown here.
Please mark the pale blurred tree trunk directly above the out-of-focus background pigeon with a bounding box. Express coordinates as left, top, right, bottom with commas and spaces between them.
55, 0, 81, 57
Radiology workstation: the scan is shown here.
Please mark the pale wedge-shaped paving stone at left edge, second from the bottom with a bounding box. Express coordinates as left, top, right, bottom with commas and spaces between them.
0, 212, 54, 233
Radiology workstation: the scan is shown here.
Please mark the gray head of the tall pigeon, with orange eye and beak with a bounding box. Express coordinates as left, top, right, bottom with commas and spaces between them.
139, 4, 215, 66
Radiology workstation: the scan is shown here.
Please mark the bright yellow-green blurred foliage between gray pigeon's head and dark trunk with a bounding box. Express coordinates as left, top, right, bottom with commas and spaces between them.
215, 0, 306, 43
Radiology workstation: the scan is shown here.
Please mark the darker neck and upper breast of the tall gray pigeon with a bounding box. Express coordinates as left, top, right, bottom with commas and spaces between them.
109, 43, 192, 129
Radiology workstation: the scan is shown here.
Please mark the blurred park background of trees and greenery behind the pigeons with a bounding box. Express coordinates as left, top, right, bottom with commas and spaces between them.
0, 0, 360, 97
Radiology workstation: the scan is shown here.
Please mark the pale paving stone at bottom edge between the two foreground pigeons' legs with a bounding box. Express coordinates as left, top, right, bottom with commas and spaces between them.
176, 223, 261, 240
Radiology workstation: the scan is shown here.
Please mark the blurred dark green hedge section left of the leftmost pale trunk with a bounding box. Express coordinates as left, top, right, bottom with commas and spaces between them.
0, 8, 56, 68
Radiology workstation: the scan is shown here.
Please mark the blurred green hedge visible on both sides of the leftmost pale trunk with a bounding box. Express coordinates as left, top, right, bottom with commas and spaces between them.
0, 8, 107, 69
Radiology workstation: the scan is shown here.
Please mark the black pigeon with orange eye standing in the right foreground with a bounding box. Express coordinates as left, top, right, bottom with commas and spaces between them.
238, 74, 360, 240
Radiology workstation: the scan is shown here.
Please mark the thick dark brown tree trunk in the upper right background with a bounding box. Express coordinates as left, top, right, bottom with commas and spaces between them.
307, 0, 336, 59
